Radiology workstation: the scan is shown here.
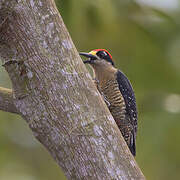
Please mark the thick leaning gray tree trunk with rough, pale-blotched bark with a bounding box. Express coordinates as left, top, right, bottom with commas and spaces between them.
0, 0, 145, 180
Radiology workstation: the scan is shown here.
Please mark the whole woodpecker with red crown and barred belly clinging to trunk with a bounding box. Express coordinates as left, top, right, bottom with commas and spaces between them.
80, 49, 137, 156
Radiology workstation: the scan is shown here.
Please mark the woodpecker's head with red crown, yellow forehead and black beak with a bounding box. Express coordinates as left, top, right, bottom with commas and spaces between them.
79, 49, 114, 67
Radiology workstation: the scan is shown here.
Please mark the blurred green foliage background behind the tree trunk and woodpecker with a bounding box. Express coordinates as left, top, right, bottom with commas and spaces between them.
0, 0, 180, 180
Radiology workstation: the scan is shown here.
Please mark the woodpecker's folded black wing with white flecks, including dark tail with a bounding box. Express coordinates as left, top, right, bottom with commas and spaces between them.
117, 70, 137, 156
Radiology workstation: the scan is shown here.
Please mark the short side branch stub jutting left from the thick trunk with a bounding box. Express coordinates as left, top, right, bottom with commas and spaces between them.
0, 87, 18, 113
